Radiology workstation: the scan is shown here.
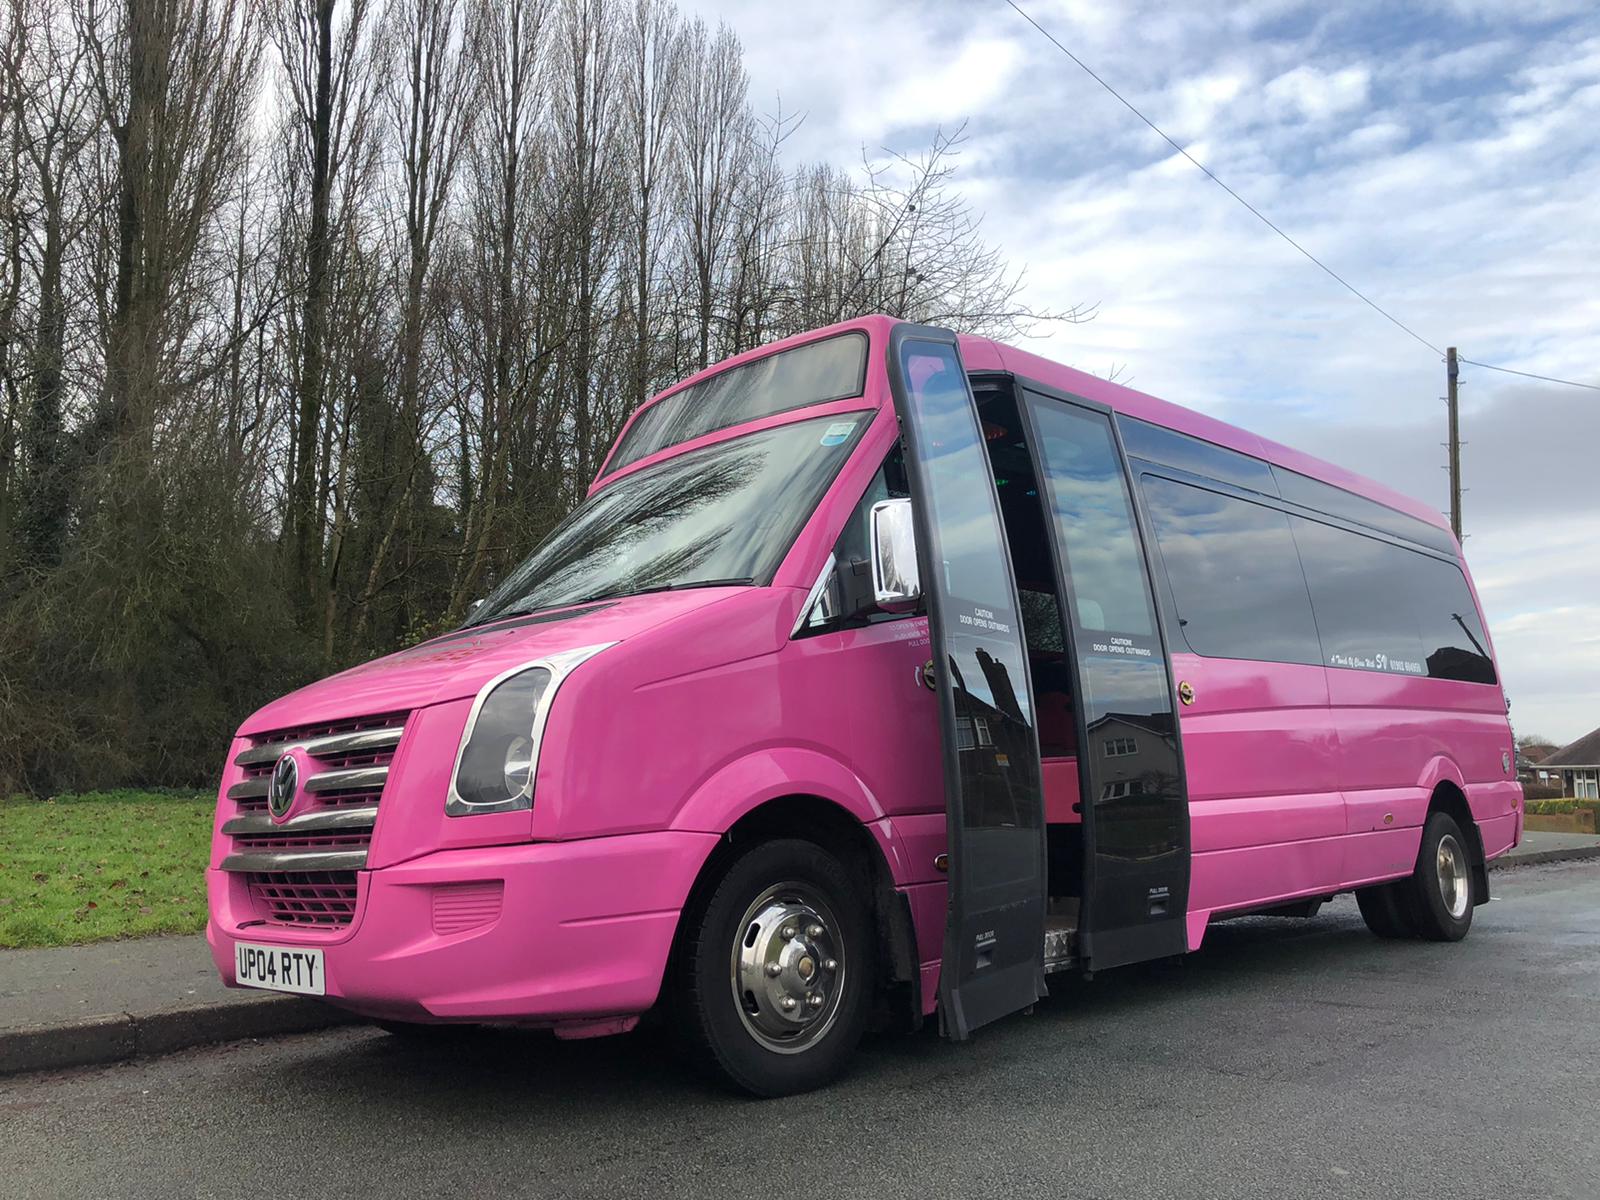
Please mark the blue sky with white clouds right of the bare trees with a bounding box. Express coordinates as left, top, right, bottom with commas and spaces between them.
707, 0, 1600, 742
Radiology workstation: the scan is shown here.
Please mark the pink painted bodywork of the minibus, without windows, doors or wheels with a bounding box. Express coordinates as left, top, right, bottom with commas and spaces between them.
206, 317, 1522, 1091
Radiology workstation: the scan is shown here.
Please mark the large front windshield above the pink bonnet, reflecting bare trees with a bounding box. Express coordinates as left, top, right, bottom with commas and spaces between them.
467, 413, 870, 626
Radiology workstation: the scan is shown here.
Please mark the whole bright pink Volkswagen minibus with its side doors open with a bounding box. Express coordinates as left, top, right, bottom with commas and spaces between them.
208, 317, 1522, 1096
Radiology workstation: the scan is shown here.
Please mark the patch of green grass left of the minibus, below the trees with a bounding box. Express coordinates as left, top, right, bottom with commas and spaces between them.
0, 790, 216, 946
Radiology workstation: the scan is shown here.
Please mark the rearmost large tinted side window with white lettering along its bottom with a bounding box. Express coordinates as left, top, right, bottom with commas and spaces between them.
1291, 517, 1494, 683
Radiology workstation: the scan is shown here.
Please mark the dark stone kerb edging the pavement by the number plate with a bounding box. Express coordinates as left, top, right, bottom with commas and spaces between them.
0, 995, 360, 1075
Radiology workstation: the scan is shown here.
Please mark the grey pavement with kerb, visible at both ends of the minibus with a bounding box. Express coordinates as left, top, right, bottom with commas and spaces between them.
0, 834, 1600, 1075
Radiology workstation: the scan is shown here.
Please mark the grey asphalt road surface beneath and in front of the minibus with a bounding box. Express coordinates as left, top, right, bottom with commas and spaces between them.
0, 862, 1600, 1200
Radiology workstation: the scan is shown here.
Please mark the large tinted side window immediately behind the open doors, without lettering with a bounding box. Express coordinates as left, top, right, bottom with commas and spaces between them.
1142, 475, 1322, 662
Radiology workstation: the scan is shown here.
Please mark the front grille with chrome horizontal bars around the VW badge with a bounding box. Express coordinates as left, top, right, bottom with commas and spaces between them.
222, 712, 406, 928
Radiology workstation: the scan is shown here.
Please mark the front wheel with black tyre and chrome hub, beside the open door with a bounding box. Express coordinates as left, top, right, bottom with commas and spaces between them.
674, 838, 877, 1096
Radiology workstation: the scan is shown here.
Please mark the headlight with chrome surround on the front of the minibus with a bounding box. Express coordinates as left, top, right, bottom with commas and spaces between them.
445, 642, 616, 816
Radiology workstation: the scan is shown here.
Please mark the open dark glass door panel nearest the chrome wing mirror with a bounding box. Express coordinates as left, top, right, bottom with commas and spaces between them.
888, 325, 1046, 1038
